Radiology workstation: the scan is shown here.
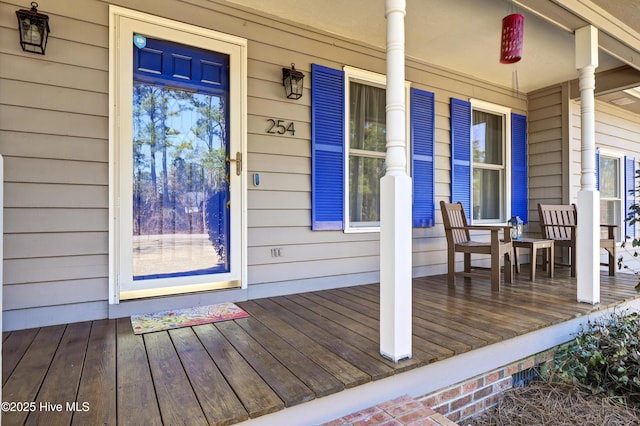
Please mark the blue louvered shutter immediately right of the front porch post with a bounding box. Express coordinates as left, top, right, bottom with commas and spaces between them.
411, 88, 435, 228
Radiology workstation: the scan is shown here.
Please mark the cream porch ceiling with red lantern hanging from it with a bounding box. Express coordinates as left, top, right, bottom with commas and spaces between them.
228, 0, 640, 112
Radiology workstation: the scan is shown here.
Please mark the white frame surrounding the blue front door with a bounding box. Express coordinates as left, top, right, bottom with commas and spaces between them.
109, 5, 247, 304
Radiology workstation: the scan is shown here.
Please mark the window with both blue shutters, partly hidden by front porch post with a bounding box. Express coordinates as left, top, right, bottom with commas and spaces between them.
311, 64, 435, 232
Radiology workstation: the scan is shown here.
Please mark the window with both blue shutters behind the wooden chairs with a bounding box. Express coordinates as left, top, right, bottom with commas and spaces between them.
451, 98, 529, 223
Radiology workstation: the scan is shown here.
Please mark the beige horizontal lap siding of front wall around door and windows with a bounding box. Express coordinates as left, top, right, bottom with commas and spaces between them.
0, 0, 526, 327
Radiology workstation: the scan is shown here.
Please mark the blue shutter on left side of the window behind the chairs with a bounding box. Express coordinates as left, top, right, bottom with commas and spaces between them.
451, 98, 473, 215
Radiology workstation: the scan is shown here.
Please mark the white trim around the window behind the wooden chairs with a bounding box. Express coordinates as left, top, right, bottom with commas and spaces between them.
469, 99, 512, 225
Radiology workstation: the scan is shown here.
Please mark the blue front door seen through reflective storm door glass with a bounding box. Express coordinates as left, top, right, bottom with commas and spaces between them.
131, 35, 231, 282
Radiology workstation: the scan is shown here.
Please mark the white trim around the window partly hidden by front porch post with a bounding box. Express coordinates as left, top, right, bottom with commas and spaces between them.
343, 66, 411, 234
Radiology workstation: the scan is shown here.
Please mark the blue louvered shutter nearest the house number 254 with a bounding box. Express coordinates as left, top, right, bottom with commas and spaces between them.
311, 64, 344, 230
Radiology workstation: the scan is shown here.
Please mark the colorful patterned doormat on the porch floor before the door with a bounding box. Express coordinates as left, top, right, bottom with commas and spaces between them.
131, 303, 250, 334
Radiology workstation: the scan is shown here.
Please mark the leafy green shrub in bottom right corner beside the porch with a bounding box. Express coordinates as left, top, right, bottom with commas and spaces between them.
551, 312, 640, 404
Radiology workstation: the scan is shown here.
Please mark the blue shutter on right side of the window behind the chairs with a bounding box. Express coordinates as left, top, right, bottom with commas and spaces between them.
511, 114, 529, 223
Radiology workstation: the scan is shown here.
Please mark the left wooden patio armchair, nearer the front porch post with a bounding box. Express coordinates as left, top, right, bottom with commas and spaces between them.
440, 201, 513, 291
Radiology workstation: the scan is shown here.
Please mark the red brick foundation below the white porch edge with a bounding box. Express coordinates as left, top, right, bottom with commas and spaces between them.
416, 349, 554, 422
